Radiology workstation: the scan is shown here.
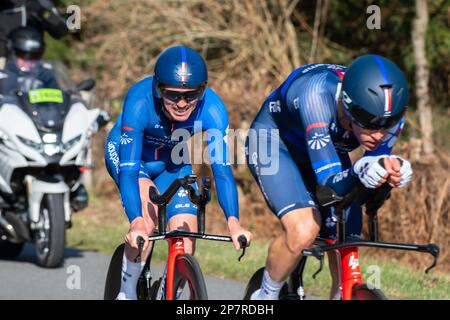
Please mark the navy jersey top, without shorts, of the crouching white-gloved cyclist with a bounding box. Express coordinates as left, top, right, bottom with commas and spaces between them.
253, 64, 404, 198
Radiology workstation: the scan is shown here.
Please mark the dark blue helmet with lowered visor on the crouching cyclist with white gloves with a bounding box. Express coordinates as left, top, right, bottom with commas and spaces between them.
342, 54, 409, 129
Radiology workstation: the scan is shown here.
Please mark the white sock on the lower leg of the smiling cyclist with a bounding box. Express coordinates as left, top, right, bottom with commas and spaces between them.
117, 252, 145, 300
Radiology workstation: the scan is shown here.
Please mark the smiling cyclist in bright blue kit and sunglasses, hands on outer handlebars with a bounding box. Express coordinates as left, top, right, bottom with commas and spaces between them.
105, 46, 251, 299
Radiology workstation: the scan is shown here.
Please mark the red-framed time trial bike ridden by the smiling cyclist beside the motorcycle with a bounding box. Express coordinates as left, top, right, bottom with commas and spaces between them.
104, 174, 247, 300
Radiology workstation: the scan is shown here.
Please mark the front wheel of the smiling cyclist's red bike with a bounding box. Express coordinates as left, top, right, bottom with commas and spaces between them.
173, 254, 208, 300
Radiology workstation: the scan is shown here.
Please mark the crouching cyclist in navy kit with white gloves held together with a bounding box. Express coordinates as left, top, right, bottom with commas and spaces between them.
246, 55, 412, 299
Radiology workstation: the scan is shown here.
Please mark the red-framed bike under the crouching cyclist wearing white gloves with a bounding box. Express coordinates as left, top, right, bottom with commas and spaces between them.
244, 183, 439, 300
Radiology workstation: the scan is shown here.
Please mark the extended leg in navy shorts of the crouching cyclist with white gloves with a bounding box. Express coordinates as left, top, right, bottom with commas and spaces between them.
246, 123, 320, 299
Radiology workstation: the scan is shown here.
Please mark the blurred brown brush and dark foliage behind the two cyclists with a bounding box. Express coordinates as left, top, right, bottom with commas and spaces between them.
47, 0, 450, 268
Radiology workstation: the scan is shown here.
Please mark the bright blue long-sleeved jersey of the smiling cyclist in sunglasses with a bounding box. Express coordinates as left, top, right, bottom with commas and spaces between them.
108, 77, 239, 221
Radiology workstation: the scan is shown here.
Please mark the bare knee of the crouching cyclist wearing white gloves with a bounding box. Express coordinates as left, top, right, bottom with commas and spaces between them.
283, 208, 320, 255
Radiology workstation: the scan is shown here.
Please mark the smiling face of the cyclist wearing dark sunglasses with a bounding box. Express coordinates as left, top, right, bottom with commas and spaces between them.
163, 87, 198, 121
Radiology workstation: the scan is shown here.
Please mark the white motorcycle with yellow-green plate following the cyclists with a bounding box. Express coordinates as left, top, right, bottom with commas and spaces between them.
0, 79, 109, 268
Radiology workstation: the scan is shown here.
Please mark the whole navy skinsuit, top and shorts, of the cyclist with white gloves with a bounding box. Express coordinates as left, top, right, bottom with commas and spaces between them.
246, 64, 404, 239
